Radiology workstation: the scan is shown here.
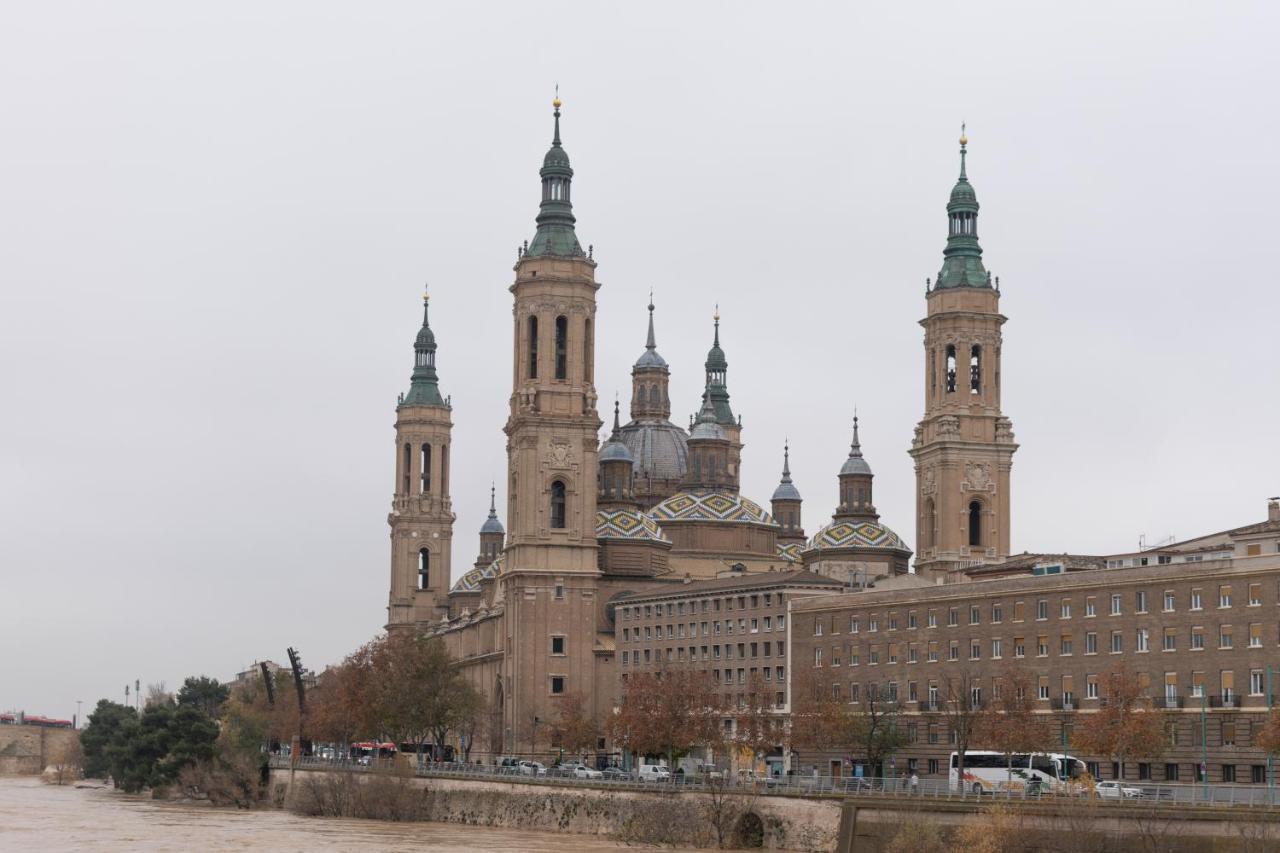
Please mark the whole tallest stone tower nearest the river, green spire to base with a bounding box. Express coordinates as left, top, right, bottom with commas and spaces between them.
500, 97, 600, 752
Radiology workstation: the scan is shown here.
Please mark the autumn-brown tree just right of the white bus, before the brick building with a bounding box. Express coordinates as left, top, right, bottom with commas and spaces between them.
1076, 663, 1166, 776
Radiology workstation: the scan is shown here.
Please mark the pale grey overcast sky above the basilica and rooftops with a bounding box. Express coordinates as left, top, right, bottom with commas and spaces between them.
0, 3, 1280, 716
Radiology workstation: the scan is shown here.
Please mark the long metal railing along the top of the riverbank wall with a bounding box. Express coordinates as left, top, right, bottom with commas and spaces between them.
270, 756, 1280, 808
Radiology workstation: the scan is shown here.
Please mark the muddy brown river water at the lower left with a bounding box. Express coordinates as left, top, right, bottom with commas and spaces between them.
0, 776, 701, 853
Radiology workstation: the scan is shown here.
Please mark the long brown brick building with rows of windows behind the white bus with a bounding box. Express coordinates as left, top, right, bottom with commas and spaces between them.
790, 501, 1280, 781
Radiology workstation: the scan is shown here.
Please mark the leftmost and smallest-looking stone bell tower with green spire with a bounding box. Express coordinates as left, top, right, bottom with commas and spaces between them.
387, 295, 453, 630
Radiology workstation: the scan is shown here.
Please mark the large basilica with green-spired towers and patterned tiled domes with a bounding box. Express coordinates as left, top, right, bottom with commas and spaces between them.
387, 99, 1016, 756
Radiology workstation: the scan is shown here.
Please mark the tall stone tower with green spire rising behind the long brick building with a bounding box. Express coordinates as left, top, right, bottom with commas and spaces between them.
910, 134, 1018, 574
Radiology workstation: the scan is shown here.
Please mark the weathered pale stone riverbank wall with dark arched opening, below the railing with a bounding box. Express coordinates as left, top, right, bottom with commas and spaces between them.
271, 770, 840, 852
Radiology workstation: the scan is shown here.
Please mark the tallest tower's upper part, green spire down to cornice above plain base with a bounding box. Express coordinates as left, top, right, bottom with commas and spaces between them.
506, 97, 602, 575
